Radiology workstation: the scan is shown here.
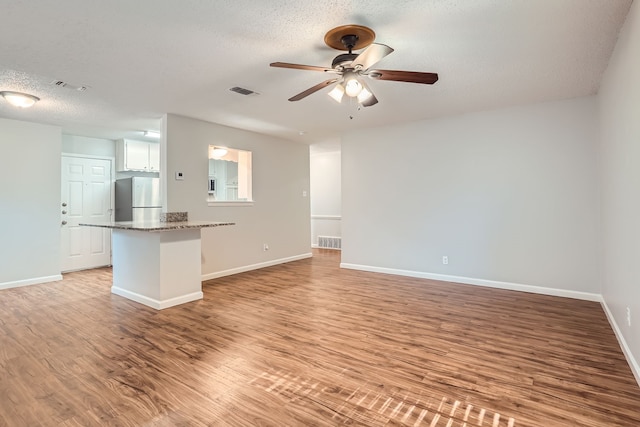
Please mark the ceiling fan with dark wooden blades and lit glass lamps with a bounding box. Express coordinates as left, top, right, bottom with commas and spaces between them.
270, 25, 438, 107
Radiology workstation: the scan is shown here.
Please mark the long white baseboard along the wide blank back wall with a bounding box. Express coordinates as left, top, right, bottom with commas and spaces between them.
340, 263, 602, 302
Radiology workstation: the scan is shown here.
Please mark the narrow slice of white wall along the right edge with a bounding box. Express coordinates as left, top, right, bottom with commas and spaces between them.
599, 1, 640, 382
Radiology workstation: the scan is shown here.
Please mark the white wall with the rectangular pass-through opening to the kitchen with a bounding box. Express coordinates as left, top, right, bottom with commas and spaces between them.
160, 114, 311, 279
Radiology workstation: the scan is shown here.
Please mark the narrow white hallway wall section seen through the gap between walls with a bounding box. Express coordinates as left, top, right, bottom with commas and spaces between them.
310, 146, 342, 246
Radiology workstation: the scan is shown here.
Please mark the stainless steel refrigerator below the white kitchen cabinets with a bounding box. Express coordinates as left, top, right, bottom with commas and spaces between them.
115, 176, 162, 221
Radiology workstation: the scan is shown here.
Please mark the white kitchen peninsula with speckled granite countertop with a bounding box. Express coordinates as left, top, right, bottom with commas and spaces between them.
80, 219, 235, 310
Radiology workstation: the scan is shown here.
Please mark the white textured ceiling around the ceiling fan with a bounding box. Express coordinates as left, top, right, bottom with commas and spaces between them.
0, 0, 632, 143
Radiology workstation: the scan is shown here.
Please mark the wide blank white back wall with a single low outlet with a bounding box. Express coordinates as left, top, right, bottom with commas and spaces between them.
342, 97, 601, 299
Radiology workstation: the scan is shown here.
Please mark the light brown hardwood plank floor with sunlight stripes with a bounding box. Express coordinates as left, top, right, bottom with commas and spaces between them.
0, 250, 640, 427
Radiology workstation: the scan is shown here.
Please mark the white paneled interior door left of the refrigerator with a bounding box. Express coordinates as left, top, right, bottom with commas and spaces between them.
60, 156, 113, 271
